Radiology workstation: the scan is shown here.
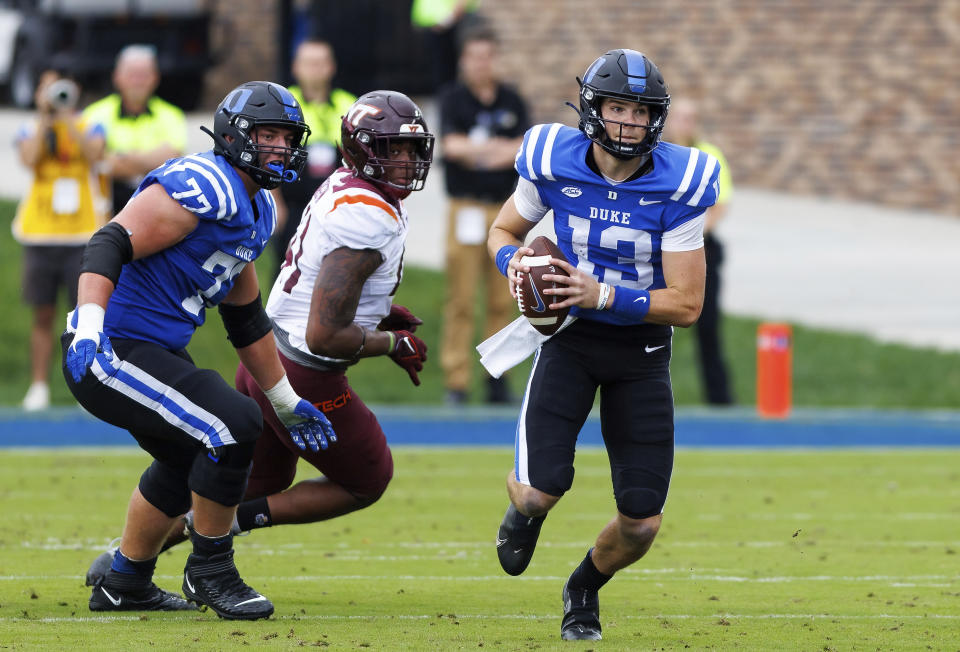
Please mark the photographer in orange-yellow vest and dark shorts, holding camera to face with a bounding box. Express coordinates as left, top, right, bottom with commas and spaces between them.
12, 70, 107, 411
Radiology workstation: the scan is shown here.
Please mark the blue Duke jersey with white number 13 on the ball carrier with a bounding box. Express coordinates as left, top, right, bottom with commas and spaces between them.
515, 123, 720, 324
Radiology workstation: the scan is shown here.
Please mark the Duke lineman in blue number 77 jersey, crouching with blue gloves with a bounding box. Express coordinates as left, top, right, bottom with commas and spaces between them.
62, 82, 336, 620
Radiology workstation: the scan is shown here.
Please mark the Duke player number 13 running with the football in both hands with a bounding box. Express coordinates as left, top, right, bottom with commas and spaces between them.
487, 50, 718, 640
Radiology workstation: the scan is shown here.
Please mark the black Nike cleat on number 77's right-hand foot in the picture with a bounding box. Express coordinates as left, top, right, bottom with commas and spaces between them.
183, 550, 273, 620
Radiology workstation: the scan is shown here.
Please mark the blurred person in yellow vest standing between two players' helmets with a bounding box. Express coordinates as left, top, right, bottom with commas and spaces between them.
270, 39, 357, 274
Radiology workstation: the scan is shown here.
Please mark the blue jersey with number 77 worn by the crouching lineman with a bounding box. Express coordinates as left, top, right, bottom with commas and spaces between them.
104, 151, 277, 350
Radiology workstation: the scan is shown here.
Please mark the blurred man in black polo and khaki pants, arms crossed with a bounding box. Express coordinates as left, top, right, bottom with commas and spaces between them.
439, 28, 529, 405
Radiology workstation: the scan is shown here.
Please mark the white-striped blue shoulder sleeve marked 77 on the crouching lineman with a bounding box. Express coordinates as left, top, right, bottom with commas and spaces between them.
153, 154, 238, 221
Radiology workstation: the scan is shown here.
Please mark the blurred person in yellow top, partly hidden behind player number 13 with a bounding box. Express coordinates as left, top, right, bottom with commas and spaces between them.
667, 99, 734, 405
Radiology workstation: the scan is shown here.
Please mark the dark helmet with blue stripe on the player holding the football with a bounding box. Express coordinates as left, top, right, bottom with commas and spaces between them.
571, 49, 670, 159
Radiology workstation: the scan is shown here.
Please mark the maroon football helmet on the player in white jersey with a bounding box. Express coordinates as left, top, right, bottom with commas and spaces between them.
340, 91, 434, 199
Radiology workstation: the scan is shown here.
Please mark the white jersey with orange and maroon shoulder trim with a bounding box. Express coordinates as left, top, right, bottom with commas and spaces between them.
267, 168, 407, 360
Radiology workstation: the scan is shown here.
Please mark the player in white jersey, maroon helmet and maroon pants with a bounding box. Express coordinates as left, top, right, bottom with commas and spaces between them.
87, 91, 434, 596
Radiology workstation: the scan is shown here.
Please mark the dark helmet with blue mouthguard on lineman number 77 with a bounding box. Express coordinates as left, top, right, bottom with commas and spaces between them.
201, 81, 310, 190
